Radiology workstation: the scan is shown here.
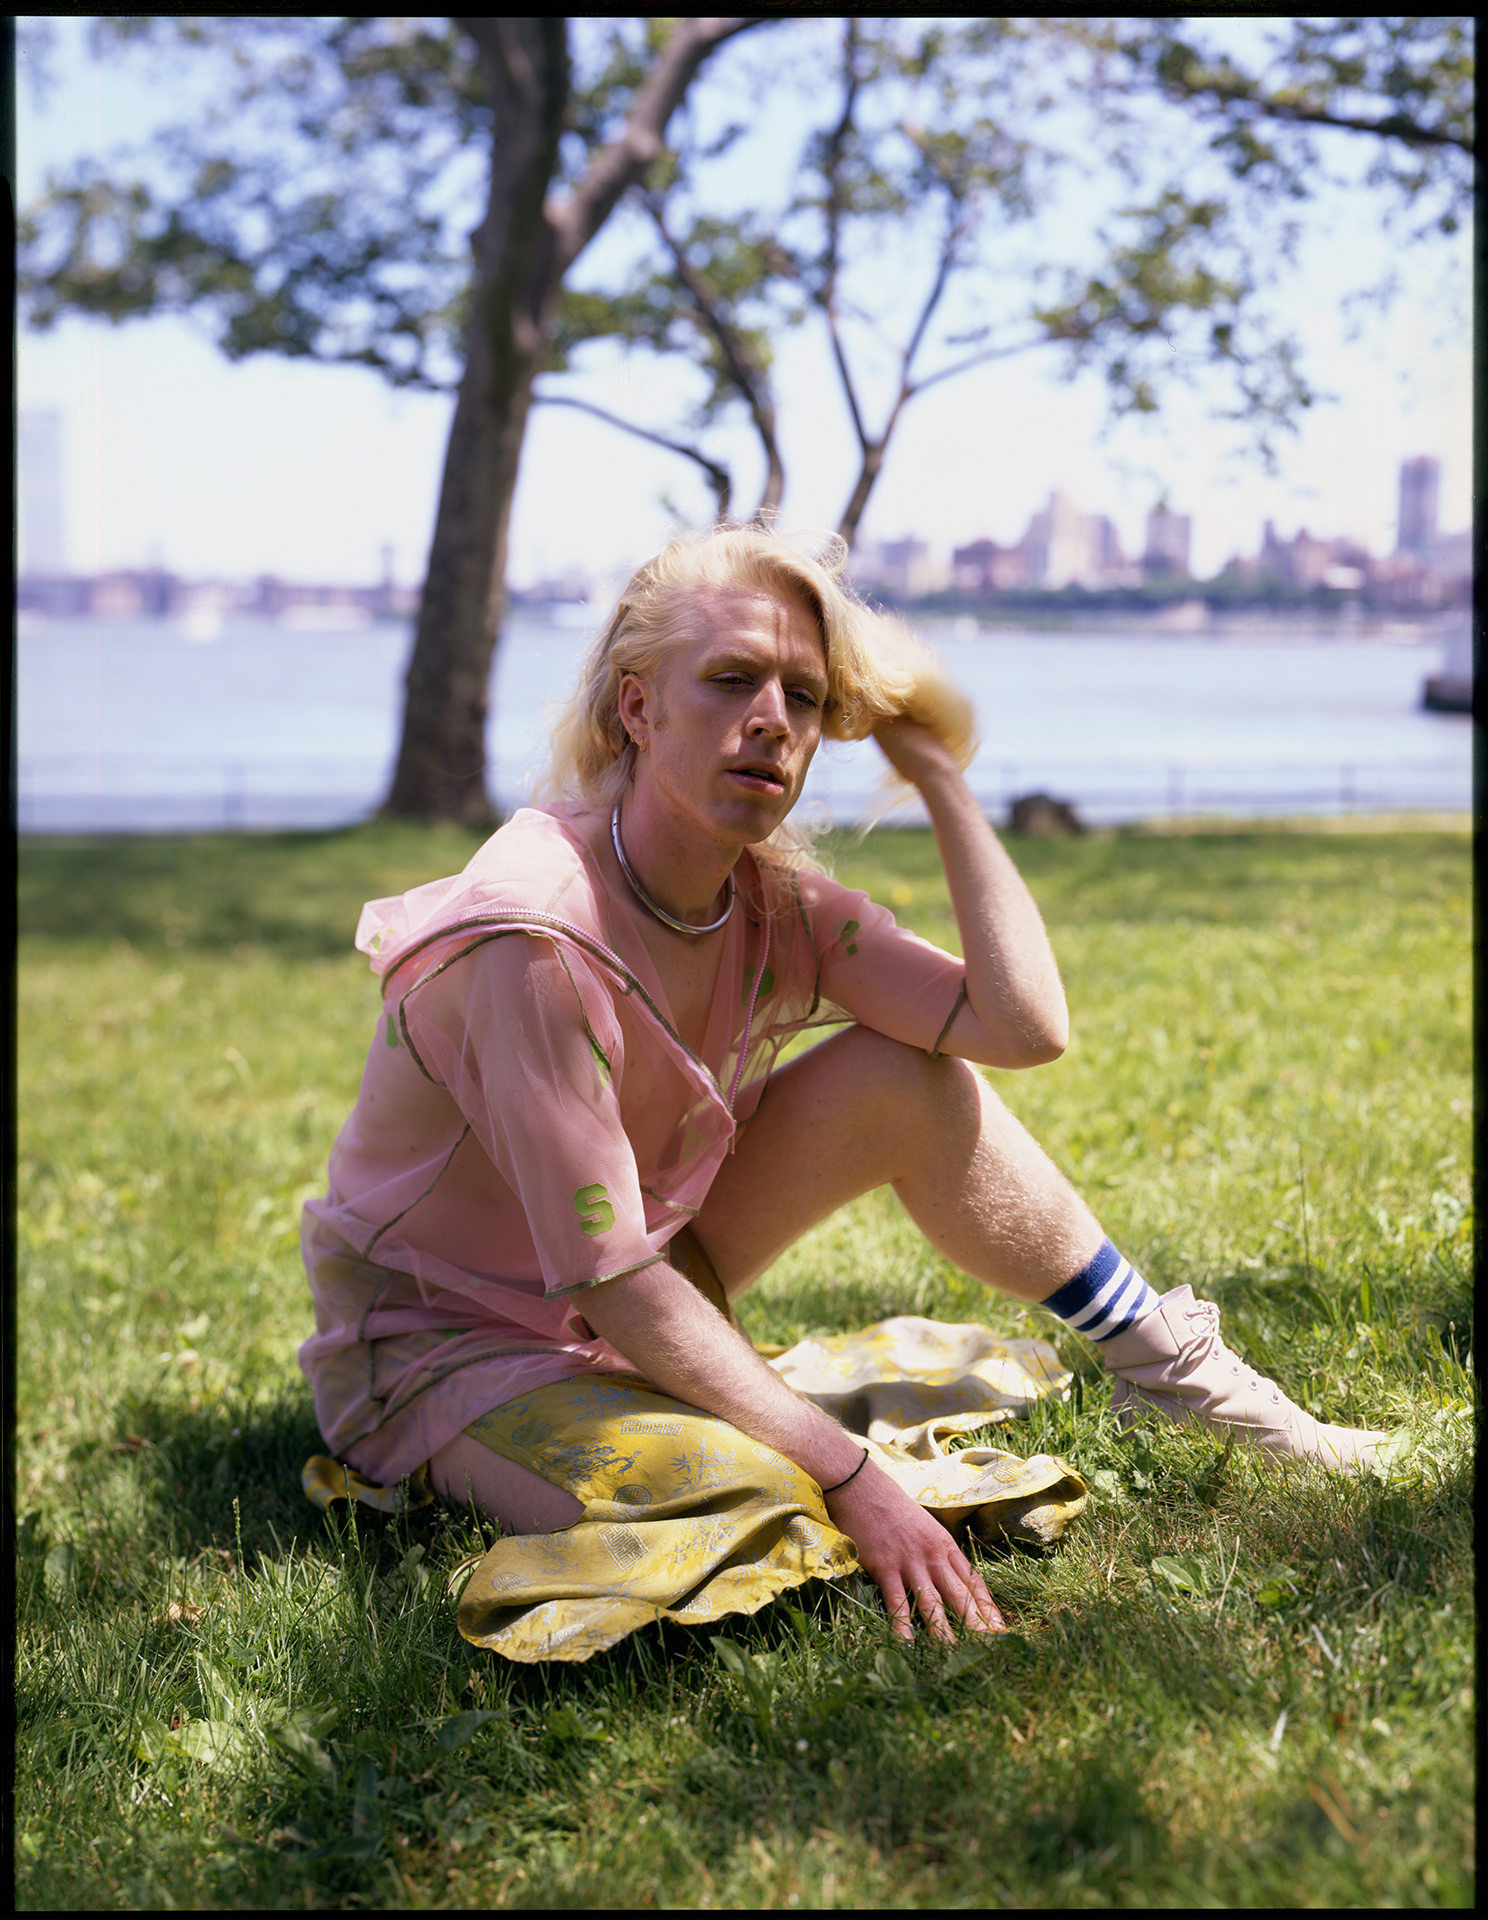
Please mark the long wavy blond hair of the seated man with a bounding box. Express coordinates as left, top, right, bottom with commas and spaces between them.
534, 526, 975, 864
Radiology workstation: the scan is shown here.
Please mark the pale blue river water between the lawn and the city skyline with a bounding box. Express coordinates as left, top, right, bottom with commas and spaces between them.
17, 614, 1471, 833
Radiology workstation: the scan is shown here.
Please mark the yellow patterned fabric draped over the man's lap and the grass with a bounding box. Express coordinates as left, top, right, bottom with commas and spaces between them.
447, 1317, 1087, 1661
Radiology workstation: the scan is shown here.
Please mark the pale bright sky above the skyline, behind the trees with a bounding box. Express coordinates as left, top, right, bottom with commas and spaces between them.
17, 19, 1471, 586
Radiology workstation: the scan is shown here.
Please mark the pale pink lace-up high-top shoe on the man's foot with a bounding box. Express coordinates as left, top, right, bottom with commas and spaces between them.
1100, 1286, 1388, 1473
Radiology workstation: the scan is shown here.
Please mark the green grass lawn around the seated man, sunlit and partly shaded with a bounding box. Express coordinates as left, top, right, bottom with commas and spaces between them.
15, 826, 1475, 1908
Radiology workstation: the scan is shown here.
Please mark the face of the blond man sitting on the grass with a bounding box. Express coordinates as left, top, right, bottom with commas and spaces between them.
620, 591, 828, 845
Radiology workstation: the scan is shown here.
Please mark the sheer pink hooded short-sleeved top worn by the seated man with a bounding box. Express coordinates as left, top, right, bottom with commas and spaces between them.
300, 808, 964, 1484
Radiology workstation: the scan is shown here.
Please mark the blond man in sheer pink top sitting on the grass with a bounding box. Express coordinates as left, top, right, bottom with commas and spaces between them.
301, 530, 1382, 1636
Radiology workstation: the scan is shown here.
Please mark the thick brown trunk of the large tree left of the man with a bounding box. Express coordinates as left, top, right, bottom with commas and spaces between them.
384, 15, 568, 824
